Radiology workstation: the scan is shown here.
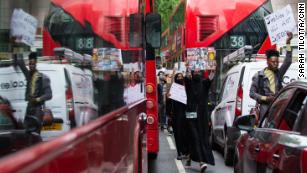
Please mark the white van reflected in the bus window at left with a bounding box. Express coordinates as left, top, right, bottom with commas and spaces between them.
0, 62, 98, 139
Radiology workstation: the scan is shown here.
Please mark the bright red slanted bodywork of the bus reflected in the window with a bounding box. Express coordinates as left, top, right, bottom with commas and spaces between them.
52, 0, 139, 49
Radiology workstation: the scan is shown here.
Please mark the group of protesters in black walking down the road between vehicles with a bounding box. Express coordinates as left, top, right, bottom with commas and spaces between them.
158, 65, 215, 172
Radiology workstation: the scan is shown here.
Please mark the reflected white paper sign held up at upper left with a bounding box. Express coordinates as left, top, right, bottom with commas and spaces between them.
11, 9, 37, 46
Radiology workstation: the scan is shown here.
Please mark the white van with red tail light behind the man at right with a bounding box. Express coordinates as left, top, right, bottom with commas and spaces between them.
211, 61, 298, 165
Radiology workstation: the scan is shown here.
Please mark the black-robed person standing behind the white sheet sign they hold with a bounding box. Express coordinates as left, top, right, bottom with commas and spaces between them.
169, 73, 187, 160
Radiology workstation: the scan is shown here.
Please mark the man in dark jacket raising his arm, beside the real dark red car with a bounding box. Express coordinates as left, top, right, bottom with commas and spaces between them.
250, 32, 293, 119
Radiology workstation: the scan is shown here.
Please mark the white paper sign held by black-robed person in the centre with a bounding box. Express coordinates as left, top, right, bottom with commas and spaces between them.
169, 83, 187, 104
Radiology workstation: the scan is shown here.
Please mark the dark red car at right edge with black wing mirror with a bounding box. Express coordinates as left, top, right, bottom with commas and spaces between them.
234, 81, 307, 173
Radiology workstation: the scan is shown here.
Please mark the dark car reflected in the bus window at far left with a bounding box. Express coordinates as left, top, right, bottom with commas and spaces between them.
0, 97, 42, 157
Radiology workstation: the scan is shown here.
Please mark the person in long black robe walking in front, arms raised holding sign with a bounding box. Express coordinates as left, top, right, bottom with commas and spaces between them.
185, 70, 215, 172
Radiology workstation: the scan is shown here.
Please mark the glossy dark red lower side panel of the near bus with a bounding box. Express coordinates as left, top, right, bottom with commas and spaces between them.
0, 100, 147, 173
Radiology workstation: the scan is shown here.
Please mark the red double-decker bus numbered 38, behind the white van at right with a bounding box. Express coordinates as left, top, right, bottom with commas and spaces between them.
162, 0, 272, 85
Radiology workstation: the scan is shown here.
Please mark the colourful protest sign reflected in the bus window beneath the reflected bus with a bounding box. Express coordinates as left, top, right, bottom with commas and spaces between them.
93, 48, 123, 71
